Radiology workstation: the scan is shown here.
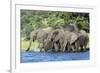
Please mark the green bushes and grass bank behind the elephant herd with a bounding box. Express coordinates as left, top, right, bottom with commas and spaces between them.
20, 9, 89, 50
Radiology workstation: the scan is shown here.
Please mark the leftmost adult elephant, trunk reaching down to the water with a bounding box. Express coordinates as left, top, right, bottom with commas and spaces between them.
26, 27, 52, 51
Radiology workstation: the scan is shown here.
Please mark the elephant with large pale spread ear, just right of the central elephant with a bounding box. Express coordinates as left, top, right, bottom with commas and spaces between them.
63, 31, 78, 51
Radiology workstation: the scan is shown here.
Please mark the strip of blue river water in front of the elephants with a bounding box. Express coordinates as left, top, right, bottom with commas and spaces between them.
20, 51, 90, 63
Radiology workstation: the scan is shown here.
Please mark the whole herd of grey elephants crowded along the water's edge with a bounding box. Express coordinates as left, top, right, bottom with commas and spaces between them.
26, 24, 89, 52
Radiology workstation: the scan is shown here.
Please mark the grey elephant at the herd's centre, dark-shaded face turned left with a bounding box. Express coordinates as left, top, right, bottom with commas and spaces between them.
51, 29, 65, 52
